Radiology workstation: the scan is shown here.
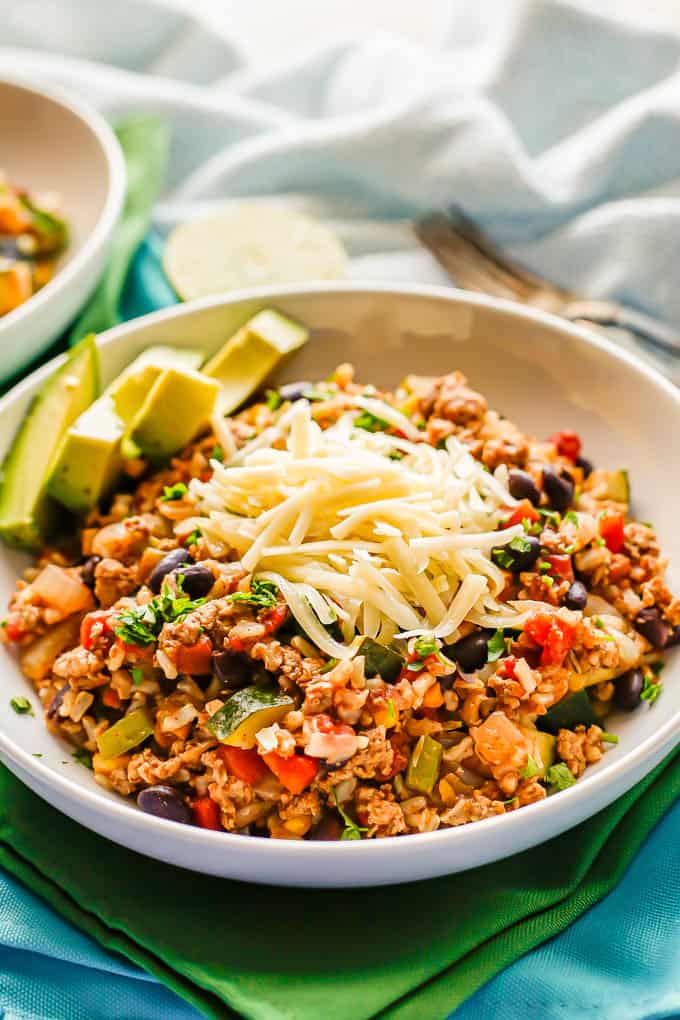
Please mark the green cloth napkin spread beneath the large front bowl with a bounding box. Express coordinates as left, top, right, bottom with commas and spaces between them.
0, 751, 680, 1020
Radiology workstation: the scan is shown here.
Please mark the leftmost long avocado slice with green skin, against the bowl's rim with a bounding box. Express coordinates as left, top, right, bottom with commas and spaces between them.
0, 335, 99, 549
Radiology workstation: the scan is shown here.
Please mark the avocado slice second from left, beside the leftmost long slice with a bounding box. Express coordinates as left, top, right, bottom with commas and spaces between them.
48, 347, 203, 513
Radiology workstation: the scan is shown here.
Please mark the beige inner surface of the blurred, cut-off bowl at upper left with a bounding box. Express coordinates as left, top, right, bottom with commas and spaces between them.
0, 82, 110, 273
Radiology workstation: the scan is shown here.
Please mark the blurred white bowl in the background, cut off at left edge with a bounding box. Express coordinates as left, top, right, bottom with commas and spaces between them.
0, 80, 125, 379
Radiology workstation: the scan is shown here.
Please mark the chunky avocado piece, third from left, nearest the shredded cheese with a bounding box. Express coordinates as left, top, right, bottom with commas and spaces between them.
122, 368, 220, 461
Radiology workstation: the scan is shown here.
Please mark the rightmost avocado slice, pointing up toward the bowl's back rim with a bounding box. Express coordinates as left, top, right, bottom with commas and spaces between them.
203, 309, 309, 414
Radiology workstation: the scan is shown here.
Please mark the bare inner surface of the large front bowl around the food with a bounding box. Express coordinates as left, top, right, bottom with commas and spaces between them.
0, 287, 680, 869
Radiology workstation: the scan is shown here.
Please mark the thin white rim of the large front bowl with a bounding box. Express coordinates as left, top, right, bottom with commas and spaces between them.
0, 281, 680, 867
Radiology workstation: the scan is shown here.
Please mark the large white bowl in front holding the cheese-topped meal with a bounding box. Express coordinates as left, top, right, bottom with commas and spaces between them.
0, 284, 680, 886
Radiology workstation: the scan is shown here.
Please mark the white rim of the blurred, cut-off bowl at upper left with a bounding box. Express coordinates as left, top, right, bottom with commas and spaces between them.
0, 73, 127, 340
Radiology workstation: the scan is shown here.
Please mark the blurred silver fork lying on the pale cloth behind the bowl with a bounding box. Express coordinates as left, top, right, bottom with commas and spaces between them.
413, 207, 680, 384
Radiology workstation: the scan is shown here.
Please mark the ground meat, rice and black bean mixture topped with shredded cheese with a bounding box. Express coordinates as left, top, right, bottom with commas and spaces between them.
3, 312, 680, 839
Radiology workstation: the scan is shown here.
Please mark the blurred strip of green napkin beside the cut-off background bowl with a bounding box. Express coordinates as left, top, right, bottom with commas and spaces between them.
68, 113, 168, 346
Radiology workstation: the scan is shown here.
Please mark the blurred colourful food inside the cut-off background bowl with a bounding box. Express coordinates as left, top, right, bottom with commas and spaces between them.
0, 170, 68, 315
